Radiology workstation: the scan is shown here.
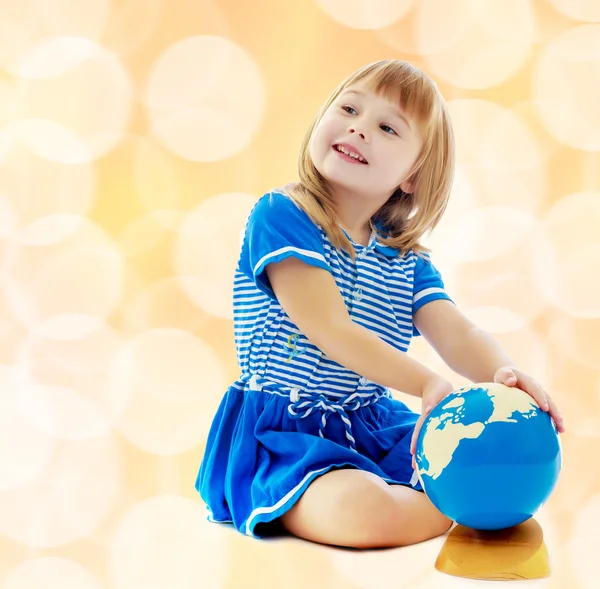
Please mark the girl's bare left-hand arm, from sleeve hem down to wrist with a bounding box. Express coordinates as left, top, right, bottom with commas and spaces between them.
266, 258, 452, 397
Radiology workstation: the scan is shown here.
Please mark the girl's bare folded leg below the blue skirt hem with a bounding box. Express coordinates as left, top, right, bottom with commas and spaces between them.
281, 469, 452, 548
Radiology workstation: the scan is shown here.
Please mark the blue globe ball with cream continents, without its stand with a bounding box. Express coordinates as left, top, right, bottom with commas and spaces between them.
415, 383, 562, 530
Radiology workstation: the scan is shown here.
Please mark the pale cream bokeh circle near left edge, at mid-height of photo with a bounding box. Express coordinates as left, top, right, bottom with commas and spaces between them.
5, 214, 124, 339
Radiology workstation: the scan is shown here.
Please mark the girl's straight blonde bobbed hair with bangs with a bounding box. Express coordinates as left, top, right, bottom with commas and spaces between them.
283, 60, 454, 257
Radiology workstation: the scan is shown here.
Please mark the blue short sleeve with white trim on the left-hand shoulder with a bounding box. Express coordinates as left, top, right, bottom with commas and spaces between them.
239, 192, 330, 299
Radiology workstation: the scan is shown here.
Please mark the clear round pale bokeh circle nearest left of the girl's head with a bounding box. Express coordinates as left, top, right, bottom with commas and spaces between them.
144, 35, 266, 162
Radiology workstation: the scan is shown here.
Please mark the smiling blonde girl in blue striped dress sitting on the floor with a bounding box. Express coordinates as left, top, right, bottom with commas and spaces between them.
196, 60, 564, 548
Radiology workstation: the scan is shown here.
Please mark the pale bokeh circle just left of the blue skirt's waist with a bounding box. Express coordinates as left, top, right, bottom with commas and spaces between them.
113, 329, 226, 456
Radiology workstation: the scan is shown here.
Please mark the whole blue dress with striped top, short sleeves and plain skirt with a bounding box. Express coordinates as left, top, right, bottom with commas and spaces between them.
196, 192, 449, 537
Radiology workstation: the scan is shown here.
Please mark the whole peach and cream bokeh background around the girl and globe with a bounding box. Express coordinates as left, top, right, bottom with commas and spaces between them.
0, 0, 600, 589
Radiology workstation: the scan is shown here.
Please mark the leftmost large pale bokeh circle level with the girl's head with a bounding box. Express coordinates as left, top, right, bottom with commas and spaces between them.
13, 37, 134, 164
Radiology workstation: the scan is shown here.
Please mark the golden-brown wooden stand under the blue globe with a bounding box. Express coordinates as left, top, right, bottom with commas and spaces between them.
435, 518, 550, 581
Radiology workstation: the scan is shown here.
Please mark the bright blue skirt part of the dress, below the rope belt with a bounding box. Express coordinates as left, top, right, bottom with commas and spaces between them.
196, 381, 423, 538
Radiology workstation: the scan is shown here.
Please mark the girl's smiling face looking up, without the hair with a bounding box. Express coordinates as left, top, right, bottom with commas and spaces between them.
309, 84, 422, 198
